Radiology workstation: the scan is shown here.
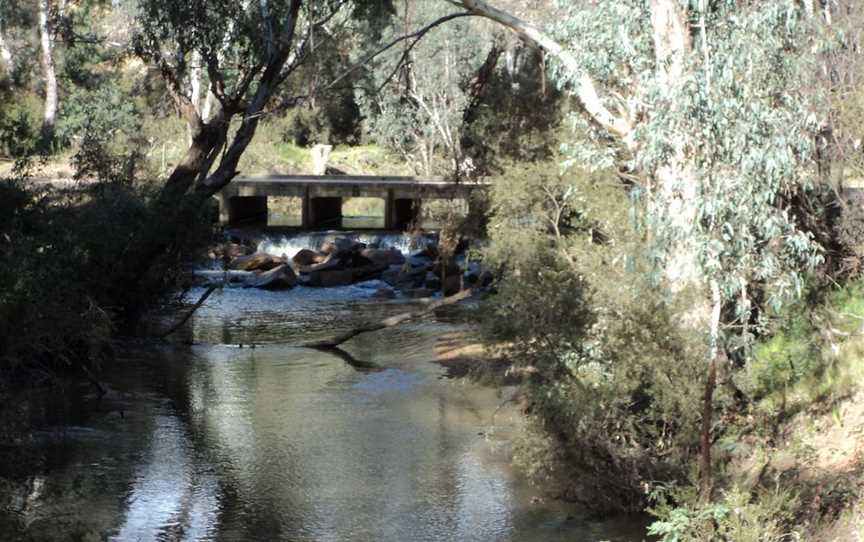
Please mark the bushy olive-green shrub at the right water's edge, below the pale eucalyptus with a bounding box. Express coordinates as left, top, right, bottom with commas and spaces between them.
484, 163, 712, 511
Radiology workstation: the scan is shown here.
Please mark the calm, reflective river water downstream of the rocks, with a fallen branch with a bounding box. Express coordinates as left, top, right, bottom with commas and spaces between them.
0, 232, 641, 542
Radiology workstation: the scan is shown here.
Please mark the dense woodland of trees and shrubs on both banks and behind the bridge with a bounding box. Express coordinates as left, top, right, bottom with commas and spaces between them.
0, 0, 864, 541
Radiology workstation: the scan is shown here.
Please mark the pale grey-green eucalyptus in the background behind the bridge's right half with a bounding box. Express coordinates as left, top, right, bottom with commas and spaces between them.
361, 1, 504, 175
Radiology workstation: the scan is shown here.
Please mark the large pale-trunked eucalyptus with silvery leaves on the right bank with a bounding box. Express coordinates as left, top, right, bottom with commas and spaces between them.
446, 0, 830, 494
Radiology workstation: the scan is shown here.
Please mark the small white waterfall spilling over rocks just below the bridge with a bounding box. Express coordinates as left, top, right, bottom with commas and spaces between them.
258, 231, 438, 258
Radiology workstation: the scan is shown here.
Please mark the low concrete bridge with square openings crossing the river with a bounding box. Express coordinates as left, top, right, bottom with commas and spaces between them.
215, 175, 488, 230
